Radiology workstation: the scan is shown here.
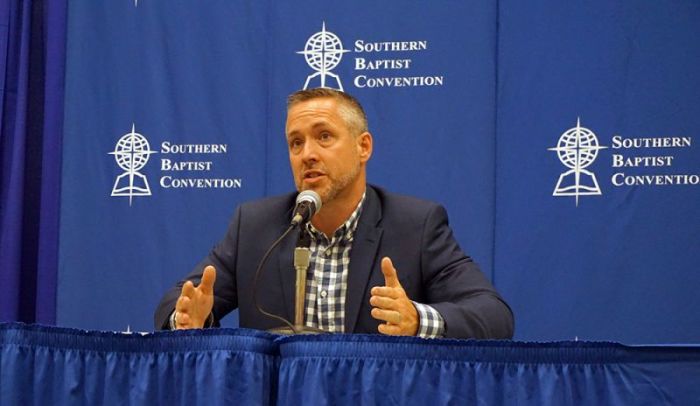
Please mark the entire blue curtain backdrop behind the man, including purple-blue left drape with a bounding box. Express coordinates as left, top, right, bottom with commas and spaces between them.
0, 0, 700, 343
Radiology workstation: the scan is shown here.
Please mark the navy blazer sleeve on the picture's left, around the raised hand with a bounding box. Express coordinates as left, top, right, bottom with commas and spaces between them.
154, 207, 241, 330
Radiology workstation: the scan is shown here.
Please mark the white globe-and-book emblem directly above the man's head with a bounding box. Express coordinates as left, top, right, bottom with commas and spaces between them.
297, 21, 350, 91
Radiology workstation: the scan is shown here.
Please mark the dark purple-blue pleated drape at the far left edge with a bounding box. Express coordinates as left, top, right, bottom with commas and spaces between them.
0, 0, 66, 324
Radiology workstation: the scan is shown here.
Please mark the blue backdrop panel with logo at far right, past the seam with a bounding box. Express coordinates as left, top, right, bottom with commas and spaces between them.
495, 1, 700, 343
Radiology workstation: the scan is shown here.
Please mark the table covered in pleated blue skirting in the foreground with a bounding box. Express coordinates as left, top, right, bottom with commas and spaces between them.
0, 323, 700, 405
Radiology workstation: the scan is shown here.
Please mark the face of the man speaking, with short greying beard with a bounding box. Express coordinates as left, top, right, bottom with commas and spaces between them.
287, 98, 371, 204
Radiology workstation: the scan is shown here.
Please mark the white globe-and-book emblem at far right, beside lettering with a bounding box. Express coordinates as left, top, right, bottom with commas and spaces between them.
548, 118, 607, 207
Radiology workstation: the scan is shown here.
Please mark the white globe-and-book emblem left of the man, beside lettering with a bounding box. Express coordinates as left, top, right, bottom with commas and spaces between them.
109, 124, 156, 206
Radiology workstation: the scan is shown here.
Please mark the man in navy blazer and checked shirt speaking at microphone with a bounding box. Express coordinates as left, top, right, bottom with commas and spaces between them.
155, 88, 513, 338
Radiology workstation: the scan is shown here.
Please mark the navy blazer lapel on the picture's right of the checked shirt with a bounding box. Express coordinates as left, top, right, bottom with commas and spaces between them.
345, 185, 383, 333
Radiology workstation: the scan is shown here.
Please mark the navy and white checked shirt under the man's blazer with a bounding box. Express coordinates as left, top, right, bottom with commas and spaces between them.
306, 195, 445, 338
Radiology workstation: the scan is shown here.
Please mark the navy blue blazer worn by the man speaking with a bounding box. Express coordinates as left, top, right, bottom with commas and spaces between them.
155, 185, 513, 338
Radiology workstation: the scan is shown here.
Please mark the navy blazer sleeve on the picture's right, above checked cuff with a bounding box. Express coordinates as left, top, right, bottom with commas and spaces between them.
421, 205, 514, 339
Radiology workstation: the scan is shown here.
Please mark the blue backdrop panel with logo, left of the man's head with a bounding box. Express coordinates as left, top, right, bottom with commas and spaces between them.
58, 1, 268, 331
